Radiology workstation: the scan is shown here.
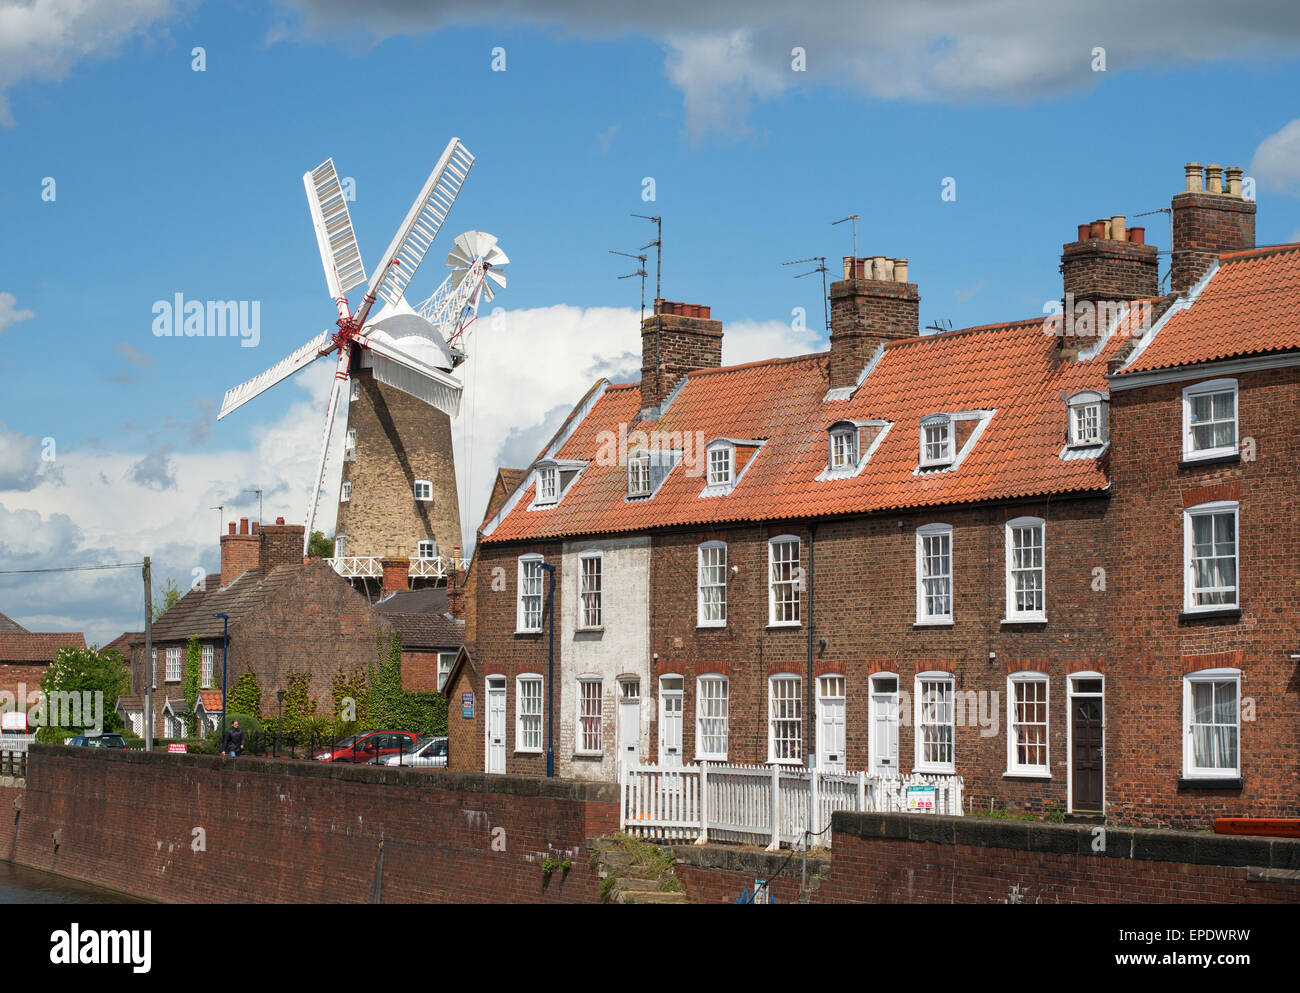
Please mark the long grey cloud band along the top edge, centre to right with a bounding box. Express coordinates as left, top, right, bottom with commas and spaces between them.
278, 0, 1300, 134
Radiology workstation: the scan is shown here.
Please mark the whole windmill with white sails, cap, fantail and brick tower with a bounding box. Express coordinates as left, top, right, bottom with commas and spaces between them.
217, 138, 510, 578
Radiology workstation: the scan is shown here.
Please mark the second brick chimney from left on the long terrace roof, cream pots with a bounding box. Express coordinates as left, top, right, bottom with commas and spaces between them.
829, 255, 920, 389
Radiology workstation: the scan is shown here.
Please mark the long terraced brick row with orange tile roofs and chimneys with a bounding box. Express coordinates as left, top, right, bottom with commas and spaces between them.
467, 159, 1300, 827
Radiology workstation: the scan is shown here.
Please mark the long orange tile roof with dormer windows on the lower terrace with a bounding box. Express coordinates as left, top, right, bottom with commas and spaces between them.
484, 318, 1127, 542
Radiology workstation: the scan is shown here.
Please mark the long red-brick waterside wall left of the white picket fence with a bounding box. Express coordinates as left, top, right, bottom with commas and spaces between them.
0, 745, 618, 903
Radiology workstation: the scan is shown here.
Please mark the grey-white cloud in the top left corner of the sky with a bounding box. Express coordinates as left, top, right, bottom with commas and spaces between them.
0, 0, 172, 125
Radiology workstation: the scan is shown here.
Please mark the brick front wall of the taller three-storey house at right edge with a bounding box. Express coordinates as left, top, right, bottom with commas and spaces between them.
1106, 369, 1300, 827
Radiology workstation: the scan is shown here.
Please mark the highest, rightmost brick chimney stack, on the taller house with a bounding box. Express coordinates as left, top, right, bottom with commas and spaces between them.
1170, 162, 1255, 294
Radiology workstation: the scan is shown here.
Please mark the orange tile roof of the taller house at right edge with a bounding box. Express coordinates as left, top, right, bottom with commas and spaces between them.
1121, 244, 1300, 374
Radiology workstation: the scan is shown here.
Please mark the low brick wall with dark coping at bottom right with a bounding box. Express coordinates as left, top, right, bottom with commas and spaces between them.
813, 814, 1300, 903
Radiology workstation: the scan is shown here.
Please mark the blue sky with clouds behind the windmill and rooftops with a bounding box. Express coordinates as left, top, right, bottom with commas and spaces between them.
0, 0, 1300, 639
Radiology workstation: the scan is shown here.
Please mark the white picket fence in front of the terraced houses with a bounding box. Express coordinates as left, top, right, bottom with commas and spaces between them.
619, 762, 962, 850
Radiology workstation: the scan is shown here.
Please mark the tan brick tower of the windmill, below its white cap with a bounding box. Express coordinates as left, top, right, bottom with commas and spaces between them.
335, 369, 462, 558
